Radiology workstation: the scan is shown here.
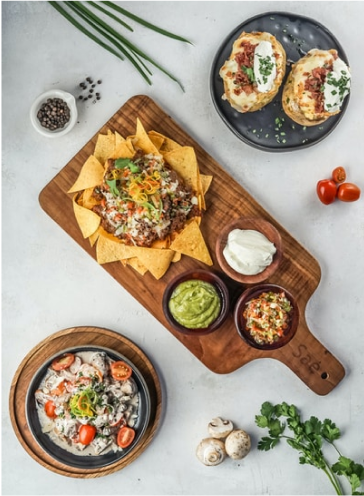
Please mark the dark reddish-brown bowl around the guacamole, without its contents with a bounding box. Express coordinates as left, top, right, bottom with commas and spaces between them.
163, 269, 229, 336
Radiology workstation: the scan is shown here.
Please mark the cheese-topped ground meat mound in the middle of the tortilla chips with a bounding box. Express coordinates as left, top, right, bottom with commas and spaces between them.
93, 151, 201, 247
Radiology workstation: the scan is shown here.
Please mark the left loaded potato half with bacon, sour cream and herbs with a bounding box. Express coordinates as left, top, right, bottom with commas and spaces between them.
219, 31, 286, 113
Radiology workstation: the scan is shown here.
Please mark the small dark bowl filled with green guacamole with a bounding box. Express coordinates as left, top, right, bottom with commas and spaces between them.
163, 269, 229, 336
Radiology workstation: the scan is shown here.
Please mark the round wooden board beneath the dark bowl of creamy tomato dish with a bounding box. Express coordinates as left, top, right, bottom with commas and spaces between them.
9, 327, 162, 479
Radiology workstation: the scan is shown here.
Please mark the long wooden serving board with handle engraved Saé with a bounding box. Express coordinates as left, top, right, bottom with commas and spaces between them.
39, 95, 345, 395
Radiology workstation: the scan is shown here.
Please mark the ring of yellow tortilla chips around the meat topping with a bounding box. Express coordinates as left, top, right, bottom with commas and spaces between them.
68, 119, 213, 279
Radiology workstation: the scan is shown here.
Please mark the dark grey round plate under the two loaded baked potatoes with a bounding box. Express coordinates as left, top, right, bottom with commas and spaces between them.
210, 12, 350, 152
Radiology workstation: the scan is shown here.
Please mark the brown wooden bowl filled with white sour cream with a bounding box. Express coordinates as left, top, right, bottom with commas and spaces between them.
216, 217, 282, 284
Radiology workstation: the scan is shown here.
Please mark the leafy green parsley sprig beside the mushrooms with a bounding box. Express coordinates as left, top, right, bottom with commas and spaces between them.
255, 401, 364, 496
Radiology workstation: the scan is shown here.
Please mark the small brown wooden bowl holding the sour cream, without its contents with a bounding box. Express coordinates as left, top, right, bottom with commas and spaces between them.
216, 217, 282, 284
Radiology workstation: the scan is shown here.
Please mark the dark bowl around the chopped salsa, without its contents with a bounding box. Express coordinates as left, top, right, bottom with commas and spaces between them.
234, 284, 299, 350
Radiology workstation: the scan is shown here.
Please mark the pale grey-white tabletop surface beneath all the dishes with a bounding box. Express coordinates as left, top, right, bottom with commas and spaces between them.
1, 0, 364, 496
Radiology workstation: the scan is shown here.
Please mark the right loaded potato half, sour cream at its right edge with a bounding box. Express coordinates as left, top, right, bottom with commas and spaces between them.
282, 48, 351, 126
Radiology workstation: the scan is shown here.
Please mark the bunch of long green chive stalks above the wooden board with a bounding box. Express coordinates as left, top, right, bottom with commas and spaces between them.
47, 0, 192, 91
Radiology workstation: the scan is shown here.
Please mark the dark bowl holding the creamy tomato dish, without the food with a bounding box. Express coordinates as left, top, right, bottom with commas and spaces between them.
25, 346, 151, 469
